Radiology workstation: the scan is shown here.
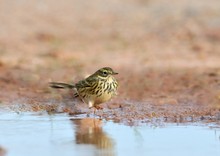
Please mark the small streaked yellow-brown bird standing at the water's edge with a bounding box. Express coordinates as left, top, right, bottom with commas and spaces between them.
50, 67, 118, 109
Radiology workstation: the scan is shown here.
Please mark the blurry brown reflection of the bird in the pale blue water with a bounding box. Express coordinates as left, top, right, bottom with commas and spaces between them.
72, 118, 114, 155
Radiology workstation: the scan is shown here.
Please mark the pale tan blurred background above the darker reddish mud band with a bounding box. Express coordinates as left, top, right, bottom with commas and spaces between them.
0, 0, 220, 69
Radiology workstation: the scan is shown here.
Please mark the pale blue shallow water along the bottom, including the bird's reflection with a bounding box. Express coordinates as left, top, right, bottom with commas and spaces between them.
0, 113, 220, 156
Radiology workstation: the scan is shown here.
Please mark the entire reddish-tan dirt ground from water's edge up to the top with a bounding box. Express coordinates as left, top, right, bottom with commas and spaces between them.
0, 0, 220, 123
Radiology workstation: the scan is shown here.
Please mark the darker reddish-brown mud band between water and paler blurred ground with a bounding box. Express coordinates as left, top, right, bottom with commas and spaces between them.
1, 66, 220, 124
